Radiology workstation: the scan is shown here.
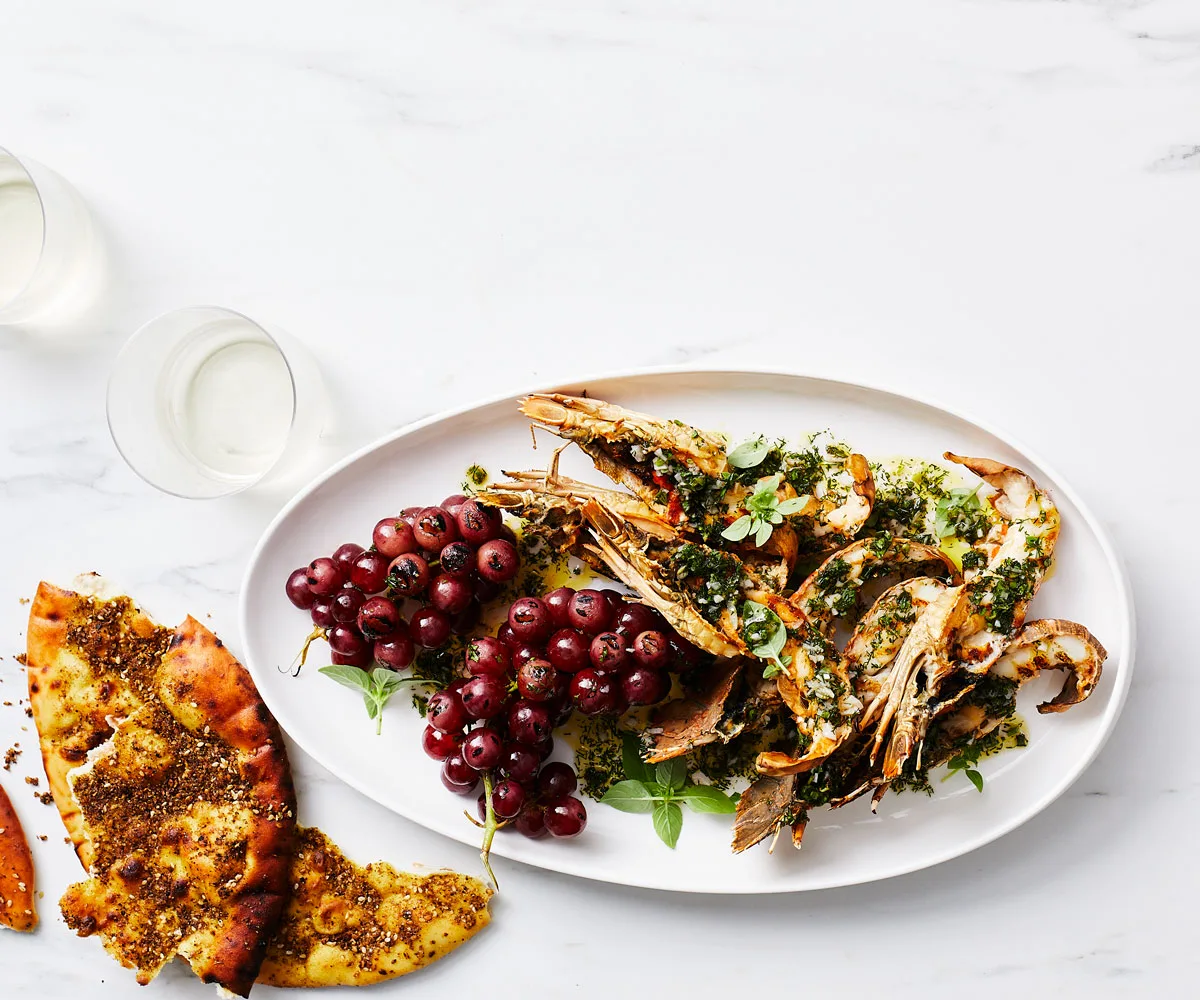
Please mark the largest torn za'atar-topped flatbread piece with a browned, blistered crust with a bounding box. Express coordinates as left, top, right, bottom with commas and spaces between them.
26, 585, 295, 996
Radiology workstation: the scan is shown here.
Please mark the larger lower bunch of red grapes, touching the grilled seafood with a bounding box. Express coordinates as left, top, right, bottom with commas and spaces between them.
421, 587, 700, 837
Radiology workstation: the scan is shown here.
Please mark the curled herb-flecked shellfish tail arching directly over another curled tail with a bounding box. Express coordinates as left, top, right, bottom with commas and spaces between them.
791, 534, 959, 633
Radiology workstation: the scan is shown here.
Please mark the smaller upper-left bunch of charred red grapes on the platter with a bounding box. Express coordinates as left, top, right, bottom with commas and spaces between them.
287, 495, 521, 670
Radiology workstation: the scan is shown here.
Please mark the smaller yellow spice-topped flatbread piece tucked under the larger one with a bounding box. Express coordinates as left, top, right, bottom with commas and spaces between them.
258, 828, 492, 987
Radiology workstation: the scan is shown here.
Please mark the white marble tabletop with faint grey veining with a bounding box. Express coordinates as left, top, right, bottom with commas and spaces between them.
0, 0, 1200, 998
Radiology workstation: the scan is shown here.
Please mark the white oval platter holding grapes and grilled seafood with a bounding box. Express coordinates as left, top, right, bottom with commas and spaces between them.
240, 370, 1134, 893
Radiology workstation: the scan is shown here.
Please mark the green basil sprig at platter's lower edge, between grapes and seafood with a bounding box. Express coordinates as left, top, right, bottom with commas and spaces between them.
600, 733, 738, 850
